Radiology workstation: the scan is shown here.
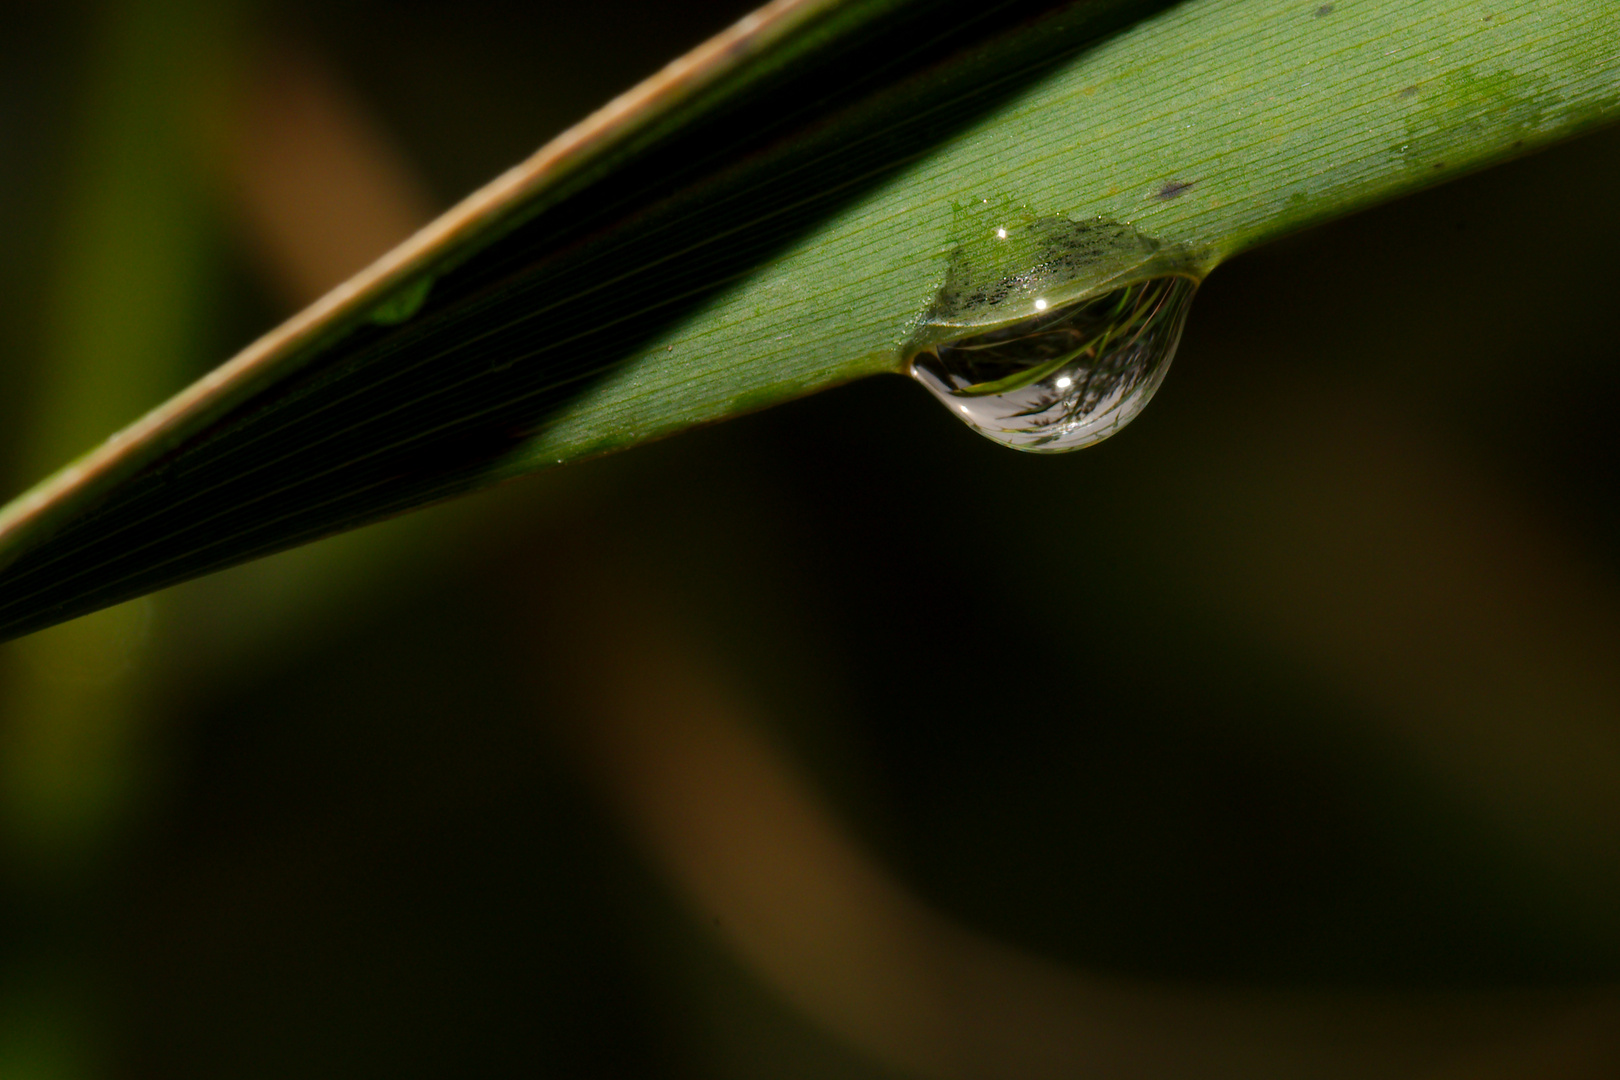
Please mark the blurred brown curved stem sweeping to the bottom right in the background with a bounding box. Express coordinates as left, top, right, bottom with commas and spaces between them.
533, 552, 1620, 1080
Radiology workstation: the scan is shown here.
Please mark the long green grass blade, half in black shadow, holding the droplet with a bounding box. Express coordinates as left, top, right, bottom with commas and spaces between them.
0, 0, 1620, 638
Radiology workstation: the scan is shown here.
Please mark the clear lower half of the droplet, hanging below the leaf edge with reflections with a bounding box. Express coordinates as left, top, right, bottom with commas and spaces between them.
910, 274, 1197, 453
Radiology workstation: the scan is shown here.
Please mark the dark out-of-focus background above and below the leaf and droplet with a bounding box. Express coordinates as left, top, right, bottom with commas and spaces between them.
0, 0, 1620, 1080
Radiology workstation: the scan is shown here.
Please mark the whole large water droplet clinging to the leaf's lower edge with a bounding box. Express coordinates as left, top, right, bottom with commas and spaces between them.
907, 219, 1199, 453
